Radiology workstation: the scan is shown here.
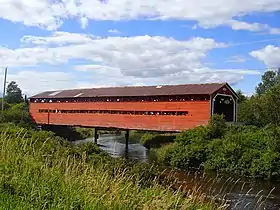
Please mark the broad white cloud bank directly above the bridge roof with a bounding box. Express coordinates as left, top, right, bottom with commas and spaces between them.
0, 32, 259, 93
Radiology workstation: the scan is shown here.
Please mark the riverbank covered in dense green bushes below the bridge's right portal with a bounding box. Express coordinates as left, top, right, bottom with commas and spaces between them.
142, 116, 280, 179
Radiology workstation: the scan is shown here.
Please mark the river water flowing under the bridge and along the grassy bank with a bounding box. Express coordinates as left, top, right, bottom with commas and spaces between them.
72, 134, 280, 210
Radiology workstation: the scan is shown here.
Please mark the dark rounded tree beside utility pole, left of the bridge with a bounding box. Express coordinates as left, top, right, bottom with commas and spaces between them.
5, 81, 23, 104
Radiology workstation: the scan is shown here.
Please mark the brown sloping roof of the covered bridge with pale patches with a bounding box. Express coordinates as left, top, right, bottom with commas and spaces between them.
31, 83, 227, 98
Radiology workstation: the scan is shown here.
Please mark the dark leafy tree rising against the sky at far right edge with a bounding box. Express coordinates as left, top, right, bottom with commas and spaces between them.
256, 68, 280, 95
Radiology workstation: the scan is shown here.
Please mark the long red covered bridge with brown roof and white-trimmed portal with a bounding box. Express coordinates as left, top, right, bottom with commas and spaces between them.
30, 83, 237, 131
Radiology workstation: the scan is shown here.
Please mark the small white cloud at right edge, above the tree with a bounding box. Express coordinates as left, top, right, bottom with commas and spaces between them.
250, 45, 280, 68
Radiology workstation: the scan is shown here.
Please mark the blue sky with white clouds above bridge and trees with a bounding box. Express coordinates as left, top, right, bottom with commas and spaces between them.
0, 0, 280, 96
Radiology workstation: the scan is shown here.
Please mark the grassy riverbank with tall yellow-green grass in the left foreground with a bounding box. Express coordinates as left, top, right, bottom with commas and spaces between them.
0, 124, 217, 209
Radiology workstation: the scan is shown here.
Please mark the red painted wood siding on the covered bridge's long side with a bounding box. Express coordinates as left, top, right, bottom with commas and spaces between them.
30, 101, 210, 131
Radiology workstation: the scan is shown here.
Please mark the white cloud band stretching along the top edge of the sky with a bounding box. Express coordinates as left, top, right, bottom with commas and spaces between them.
0, 0, 280, 32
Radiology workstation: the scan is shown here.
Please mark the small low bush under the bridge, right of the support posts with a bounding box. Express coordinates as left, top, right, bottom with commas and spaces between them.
140, 133, 176, 148
